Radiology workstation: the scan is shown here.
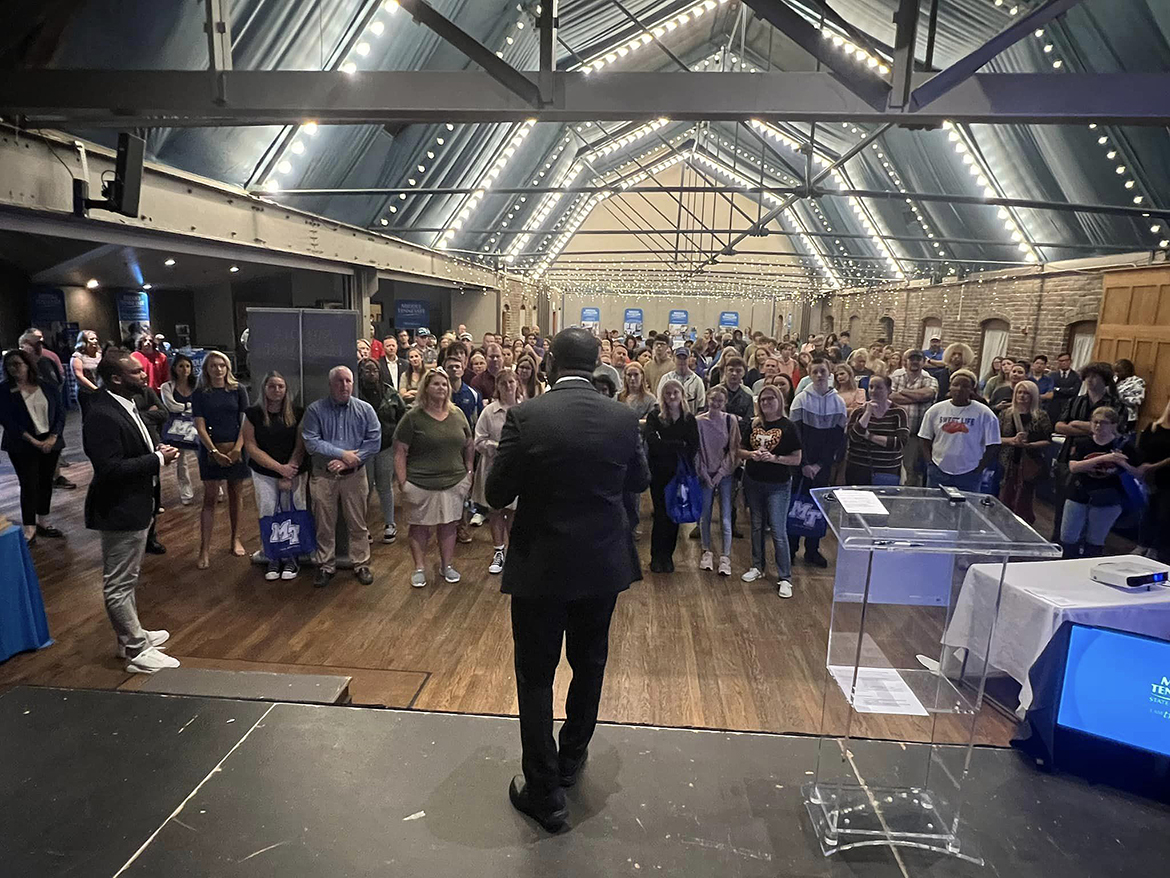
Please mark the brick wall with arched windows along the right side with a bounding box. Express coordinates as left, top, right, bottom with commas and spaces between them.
826, 272, 1103, 365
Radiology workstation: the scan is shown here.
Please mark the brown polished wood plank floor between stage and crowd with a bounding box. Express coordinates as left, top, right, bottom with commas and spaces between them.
0, 416, 1012, 746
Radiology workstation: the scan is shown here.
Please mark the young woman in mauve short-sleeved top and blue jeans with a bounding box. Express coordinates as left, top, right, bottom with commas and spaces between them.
695, 384, 739, 576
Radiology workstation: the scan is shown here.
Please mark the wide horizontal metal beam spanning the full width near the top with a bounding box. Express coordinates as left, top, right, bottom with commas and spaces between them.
9, 69, 1170, 129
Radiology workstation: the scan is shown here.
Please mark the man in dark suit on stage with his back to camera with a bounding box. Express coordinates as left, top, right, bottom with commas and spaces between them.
486, 329, 649, 832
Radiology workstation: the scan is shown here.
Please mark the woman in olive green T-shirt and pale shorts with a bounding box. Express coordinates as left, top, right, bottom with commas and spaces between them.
394, 369, 475, 589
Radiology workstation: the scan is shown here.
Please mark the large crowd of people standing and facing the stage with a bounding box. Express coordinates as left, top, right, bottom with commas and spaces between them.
0, 327, 1170, 671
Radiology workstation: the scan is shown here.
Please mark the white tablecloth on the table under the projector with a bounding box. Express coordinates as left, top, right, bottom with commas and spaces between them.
943, 557, 1170, 716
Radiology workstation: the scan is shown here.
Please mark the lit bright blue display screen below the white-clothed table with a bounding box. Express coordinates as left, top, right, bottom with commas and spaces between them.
1057, 625, 1170, 756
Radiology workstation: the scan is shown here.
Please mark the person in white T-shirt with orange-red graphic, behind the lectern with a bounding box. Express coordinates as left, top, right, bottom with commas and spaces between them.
918, 369, 999, 491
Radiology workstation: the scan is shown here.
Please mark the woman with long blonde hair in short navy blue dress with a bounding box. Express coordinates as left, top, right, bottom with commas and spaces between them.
191, 350, 248, 570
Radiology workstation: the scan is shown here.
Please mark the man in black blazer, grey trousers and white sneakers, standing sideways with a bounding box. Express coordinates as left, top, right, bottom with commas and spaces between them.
82, 348, 179, 674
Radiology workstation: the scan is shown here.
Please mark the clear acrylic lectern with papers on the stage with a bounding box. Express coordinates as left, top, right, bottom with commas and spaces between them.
803, 487, 1060, 863
